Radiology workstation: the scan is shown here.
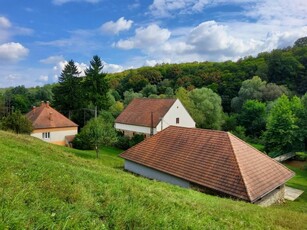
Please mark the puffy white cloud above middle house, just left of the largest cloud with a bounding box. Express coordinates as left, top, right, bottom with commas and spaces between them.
114, 24, 171, 49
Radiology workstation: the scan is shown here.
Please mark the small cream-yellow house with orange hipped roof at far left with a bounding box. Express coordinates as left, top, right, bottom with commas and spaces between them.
26, 101, 78, 145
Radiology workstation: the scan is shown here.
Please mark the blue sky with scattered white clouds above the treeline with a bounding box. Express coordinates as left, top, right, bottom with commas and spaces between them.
0, 0, 307, 88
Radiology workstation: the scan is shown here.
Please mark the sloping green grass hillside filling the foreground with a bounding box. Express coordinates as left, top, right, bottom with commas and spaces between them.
0, 131, 307, 229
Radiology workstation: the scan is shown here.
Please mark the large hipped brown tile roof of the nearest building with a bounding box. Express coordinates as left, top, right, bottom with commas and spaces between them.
120, 126, 294, 202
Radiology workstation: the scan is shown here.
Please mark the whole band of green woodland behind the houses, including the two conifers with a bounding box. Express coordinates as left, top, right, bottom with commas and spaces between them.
0, 37, 307, 156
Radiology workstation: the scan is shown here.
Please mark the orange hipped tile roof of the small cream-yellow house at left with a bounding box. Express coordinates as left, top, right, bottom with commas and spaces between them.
26, 103, 78, 129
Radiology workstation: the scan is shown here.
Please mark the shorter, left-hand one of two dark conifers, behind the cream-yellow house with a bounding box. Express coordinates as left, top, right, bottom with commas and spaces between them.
52, 60, 83, 116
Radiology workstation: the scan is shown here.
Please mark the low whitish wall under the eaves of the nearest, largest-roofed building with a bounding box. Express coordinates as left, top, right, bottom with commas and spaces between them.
125, 160, 190, 188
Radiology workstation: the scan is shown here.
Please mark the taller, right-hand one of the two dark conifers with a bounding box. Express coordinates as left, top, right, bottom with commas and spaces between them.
84, 55, 110, 110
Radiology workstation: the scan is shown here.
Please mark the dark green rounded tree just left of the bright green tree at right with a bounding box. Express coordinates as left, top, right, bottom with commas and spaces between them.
238, 100, 266, 137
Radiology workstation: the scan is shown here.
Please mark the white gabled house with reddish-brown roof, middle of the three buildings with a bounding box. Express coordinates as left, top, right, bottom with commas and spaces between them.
115, 98, 195, 136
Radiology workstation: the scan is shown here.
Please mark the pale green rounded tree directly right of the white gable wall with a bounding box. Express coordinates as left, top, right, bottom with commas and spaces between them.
189, 88, 224, 129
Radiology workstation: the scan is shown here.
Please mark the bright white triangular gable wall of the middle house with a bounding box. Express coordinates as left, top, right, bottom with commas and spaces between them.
157, 99, 195, 132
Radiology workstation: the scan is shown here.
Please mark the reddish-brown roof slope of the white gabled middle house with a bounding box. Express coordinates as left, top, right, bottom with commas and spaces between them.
115, 98, 176, 127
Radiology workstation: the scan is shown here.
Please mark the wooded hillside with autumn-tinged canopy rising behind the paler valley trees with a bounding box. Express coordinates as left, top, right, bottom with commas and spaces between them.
108, 37, 307, 112
